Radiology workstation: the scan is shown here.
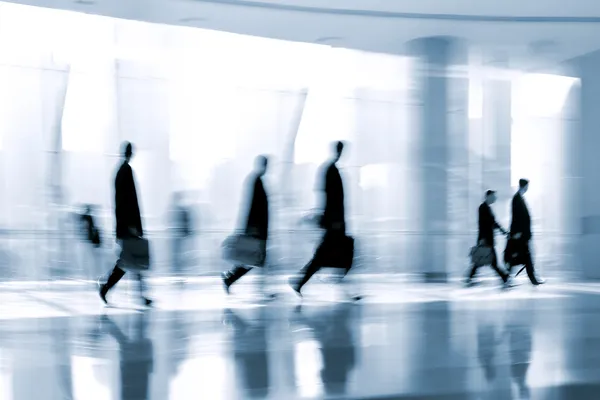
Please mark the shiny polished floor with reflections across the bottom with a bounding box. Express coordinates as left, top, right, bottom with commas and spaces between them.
0, 280, 600, 400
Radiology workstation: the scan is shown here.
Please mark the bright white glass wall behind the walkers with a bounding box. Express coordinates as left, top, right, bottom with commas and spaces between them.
0, 4, 576, 280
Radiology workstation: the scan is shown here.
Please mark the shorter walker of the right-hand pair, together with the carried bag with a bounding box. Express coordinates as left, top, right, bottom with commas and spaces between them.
466, 190, 509, 286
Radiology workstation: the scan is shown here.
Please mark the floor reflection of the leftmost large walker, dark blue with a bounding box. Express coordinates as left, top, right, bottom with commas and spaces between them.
102, 313, 154, 400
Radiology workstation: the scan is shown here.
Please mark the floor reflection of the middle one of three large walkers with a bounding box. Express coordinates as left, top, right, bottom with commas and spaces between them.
225, 309, 270, 399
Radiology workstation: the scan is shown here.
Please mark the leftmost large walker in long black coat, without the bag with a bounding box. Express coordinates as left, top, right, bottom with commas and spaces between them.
100, 142, 152, 306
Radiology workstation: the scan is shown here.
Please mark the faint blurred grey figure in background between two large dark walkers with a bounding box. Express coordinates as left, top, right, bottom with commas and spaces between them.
171, 192, 192, 278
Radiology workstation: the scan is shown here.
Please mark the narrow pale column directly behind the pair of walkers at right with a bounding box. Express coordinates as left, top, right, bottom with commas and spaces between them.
481, 55, 512, 224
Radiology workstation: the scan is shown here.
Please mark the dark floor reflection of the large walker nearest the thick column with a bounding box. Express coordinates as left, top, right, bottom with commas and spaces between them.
296, 303, 356, 396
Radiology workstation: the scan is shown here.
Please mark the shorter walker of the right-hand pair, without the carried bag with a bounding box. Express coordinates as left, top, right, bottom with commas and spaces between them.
466, 190, 509, 285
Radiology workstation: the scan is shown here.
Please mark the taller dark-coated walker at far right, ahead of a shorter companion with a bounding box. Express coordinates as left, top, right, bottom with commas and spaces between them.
505, 179, 544, 286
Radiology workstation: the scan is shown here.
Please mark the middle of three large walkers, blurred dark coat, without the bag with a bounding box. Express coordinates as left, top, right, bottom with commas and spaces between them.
221, 156, 269, 294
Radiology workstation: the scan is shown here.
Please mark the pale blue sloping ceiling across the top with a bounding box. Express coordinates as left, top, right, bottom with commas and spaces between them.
4, 0, 600, 68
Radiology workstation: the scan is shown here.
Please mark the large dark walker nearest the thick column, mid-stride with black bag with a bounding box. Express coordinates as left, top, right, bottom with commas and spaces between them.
290, 142, 360, 300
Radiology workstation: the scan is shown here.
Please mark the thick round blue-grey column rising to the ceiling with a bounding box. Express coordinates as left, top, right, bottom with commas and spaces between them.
409, 37, 468, 282
